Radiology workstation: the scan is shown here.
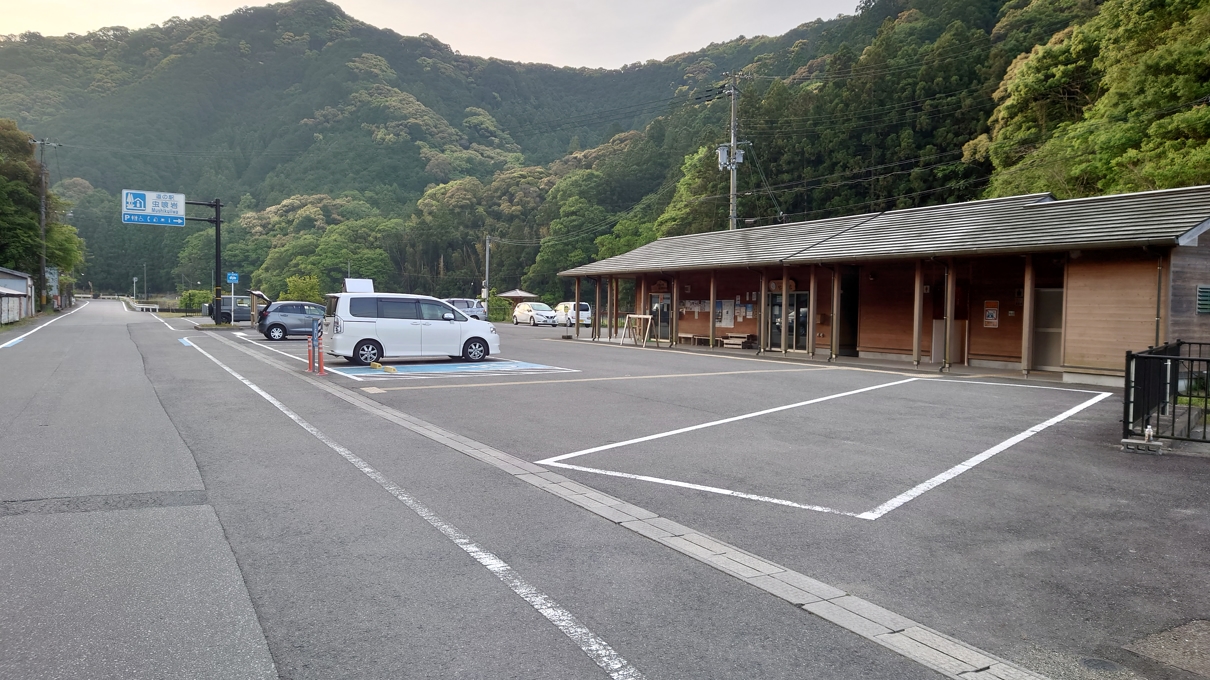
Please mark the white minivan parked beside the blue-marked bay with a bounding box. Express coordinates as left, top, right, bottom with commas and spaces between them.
323, 293, 500, 365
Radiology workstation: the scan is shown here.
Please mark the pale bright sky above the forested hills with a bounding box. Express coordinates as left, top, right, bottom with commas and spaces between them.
0, 0, 857, 68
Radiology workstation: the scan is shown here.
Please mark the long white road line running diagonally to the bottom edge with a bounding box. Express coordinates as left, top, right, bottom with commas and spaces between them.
181, 336, 644, 680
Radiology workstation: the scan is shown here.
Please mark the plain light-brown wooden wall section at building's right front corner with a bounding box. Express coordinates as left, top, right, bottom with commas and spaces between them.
1064, 250, 1166, 373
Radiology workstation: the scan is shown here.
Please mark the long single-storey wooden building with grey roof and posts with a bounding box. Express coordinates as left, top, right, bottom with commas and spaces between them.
560, 186, 1210, 385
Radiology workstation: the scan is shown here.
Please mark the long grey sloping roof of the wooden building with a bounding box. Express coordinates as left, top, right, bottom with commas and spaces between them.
561, 186, 1210, 276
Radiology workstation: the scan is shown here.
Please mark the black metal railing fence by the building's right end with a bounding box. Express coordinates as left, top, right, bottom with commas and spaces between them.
1122, 340, 1210, 442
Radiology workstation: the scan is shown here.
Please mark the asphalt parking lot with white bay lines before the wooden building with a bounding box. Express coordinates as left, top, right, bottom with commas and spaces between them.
205, 324, 1210, 679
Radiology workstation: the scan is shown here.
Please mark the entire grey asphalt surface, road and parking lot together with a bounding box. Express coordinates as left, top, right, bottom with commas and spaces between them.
0, 301, 1210, 679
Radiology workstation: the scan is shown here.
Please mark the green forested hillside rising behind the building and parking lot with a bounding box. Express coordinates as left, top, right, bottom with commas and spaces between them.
0, 0, 1210, 298
